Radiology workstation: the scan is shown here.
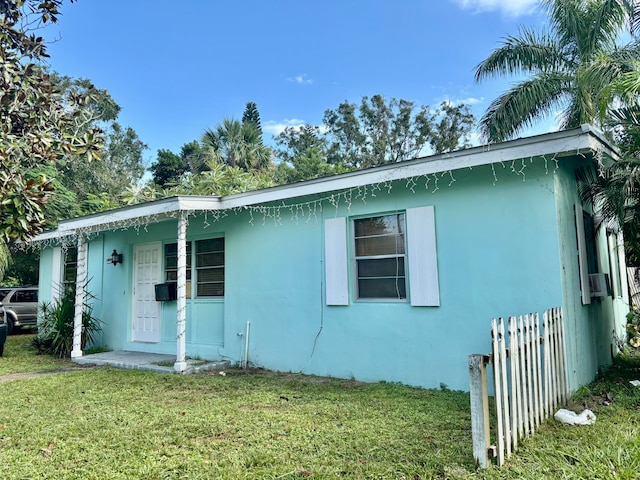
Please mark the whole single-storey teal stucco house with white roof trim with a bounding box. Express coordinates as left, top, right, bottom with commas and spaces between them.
35, 126, 628, 390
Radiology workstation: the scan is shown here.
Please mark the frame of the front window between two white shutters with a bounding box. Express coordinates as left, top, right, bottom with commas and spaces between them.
349, 210, 410, 303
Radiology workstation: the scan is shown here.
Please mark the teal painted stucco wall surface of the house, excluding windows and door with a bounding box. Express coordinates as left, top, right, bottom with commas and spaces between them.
41, 159, 628, 390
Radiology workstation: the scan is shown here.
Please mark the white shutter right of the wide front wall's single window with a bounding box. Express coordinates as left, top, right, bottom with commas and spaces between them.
407, 205, 440, 307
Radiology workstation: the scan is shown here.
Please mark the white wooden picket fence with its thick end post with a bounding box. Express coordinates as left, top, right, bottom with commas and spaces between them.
469, 308, 569, 467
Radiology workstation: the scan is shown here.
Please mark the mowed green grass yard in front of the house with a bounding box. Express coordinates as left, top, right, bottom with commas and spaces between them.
0, 336, 640, 479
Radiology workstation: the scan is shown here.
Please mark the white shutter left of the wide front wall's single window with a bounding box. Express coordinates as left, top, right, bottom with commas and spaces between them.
324, 217, 349, 305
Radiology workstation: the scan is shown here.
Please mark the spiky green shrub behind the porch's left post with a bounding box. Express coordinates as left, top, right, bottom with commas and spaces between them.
32, 287, 102, 358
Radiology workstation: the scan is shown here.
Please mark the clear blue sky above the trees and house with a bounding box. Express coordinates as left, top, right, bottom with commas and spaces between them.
44, 0, 553, 163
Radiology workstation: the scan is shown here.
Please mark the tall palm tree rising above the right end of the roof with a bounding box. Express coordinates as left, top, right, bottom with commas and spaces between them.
475, 0, 640, 142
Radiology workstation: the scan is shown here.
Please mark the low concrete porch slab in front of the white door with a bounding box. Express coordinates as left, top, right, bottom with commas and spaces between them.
72, 350, 230, 373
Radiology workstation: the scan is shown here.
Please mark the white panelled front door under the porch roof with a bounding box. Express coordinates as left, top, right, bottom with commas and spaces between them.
132, 242, 162, 342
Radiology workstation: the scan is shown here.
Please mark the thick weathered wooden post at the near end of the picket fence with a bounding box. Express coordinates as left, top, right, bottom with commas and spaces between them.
469, 354, 491, 468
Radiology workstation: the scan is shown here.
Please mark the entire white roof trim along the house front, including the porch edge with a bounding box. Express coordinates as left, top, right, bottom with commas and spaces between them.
34, 125, 618, 241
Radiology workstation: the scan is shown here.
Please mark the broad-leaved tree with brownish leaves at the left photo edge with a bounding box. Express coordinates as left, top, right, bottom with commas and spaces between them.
0, 0, 100, 241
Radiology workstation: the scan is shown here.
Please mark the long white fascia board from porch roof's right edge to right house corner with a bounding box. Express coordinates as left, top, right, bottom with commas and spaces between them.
220, 129, 610, 209
